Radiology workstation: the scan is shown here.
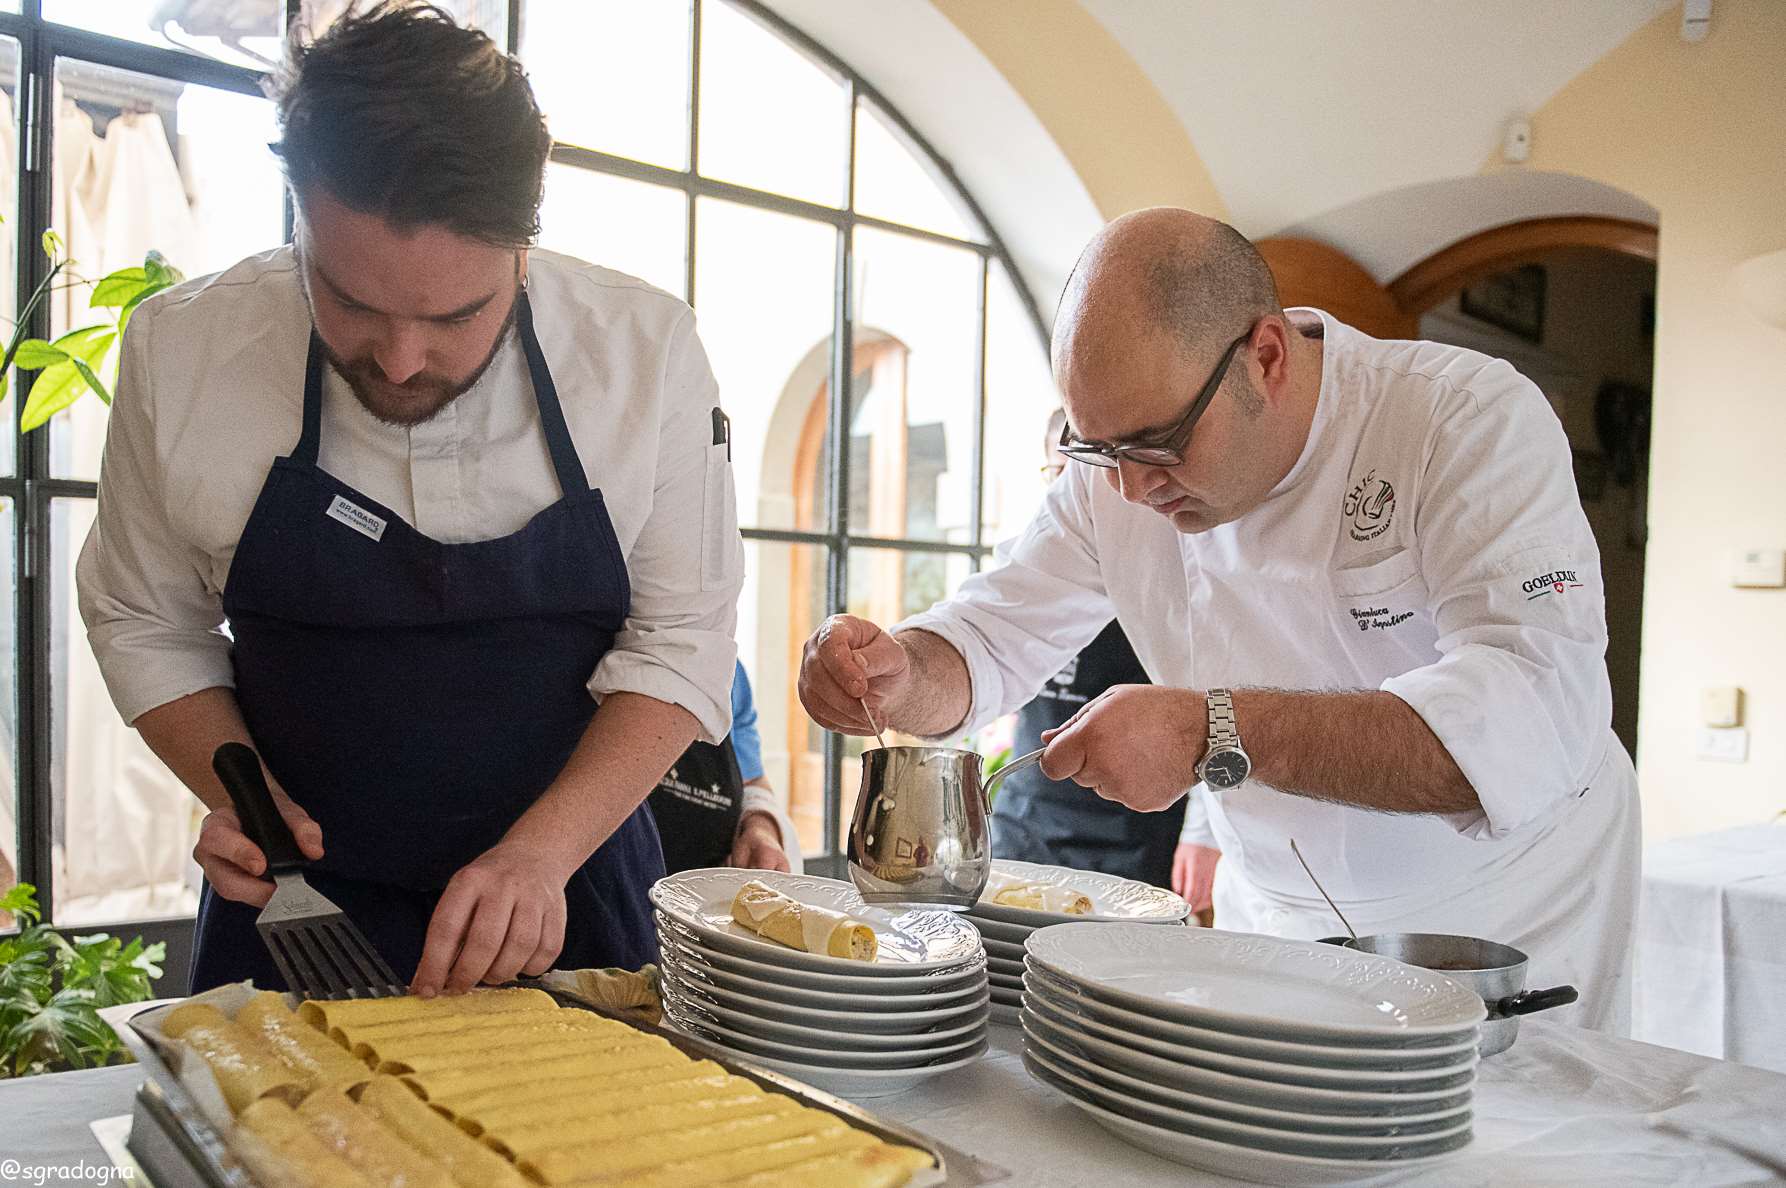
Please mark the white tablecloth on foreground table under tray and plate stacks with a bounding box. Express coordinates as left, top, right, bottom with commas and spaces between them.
13, 1018, 1786, 1188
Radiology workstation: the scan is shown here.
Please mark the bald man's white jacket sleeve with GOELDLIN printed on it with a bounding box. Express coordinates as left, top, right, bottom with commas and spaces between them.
1381, 364, 1616, 838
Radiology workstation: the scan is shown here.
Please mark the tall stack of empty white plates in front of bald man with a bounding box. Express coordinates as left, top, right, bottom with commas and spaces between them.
1023, 924, 1486, 1184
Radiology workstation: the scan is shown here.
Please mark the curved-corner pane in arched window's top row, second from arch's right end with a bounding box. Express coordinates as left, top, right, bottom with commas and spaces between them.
698, 0, 850, 205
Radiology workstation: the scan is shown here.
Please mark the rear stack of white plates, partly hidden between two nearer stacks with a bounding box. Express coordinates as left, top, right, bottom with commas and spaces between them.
966, 858, 1191, 1025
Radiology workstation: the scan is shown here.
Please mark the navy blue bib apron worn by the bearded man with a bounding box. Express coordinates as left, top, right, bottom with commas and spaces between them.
193, 293, 663, 991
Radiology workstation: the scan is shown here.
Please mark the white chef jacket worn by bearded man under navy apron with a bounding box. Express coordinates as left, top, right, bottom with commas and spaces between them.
77, 247, 743, 743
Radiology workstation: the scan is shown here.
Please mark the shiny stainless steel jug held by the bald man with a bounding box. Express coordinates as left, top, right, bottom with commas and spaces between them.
847, 747, 1041, 911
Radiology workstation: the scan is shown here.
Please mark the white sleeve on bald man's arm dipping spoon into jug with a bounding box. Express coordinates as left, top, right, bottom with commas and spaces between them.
893, 466, 1116, 731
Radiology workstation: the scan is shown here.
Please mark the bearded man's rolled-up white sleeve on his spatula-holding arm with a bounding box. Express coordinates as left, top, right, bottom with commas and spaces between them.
75, 302, 236, 724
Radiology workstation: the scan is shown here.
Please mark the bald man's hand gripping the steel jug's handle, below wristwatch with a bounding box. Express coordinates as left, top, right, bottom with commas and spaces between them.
1041, 684, 1207, 813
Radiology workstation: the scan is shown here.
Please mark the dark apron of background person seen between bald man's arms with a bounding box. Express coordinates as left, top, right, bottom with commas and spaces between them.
991, 620, 1184, 888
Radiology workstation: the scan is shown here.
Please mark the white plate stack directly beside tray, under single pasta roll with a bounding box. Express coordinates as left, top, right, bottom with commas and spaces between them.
652, 868, 988, 1097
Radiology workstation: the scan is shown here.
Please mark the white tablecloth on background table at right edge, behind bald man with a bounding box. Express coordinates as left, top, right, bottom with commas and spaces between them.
1632, 825, 1786, 1071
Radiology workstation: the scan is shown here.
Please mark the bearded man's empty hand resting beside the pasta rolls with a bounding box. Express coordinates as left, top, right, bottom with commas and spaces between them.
409, 841, 568, 999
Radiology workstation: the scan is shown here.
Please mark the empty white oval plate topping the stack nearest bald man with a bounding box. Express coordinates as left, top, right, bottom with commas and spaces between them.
1027, 924, 1488, 1043
